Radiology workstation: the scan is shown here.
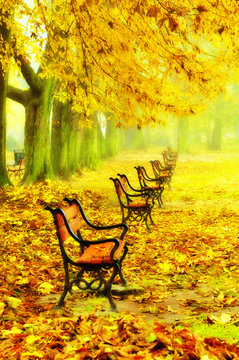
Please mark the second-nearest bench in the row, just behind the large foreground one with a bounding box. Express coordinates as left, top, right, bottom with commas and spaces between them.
110, 174, 154, 232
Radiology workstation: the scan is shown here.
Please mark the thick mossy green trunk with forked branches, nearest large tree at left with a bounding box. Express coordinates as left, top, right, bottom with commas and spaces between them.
8, 56, 54, 184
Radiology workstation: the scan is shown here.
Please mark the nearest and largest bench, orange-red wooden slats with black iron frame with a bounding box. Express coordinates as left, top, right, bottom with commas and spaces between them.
45, 198, 128, 310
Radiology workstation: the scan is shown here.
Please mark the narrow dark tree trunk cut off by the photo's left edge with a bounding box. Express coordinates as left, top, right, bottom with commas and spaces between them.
0, 11, 10, 187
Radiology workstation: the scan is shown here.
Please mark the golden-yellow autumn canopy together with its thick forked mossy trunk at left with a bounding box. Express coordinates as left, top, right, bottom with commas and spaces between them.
0, 0, 238, 182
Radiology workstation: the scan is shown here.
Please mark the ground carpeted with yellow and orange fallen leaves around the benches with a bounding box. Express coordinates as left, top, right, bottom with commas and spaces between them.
0, 149, 239, 360
